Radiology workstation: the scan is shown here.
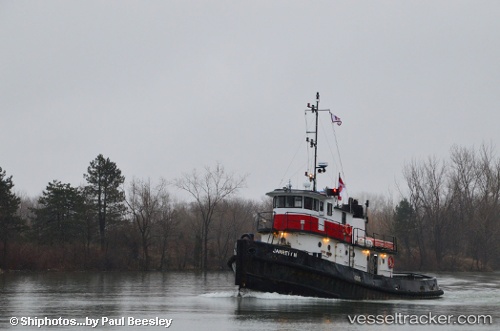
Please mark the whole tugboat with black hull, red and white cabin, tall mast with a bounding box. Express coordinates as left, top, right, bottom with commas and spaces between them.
228, 93, 444, 300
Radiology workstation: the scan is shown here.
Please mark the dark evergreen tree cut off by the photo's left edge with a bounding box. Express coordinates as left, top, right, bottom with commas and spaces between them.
0, 167, 22, 268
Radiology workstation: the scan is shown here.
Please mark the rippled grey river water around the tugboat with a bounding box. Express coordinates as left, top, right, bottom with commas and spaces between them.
0, 272, 500, 331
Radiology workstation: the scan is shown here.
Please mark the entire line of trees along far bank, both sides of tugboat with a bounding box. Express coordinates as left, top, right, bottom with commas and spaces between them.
0, 144, 500, 270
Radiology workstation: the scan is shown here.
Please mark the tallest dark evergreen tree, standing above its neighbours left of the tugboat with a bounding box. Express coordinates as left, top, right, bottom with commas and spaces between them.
84, 154, 125, 251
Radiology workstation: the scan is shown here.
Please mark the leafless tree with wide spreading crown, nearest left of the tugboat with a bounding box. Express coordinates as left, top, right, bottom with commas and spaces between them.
174, 163, 246, 270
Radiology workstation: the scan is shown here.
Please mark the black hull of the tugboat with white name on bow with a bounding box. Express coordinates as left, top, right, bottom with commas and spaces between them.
230, 239, 443, 300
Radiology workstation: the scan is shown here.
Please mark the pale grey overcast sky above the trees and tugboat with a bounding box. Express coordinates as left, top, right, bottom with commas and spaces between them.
0, 0, 500, 200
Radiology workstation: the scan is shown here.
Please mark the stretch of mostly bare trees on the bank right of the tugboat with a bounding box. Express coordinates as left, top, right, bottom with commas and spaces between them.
369, 144, 500, 271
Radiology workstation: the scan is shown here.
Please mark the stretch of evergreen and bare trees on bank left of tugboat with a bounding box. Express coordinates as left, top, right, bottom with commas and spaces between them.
0, 155, 254, 270
